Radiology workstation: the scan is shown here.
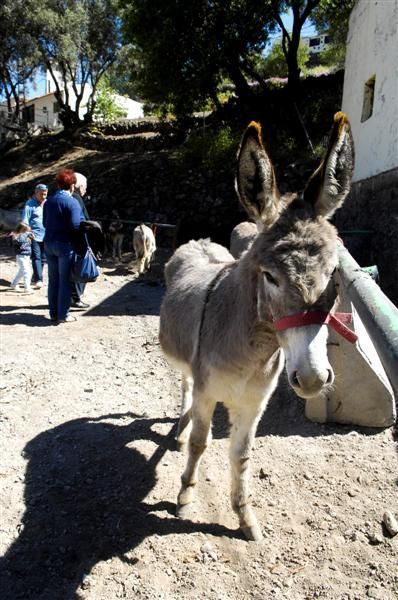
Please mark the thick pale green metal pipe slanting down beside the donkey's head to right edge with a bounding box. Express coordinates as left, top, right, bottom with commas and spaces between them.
338, 242, 398, 393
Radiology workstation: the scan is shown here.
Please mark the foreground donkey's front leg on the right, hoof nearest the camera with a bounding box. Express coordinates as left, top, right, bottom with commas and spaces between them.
230, 405, 263, 541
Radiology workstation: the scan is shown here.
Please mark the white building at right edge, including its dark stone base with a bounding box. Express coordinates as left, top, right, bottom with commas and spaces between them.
335, 0, 398, 306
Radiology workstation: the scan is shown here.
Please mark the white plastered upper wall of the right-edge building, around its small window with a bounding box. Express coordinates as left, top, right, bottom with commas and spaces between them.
343, 0, 398, 181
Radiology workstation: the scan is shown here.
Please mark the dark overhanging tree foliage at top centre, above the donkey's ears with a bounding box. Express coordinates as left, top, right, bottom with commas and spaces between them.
121, 0, 353, 116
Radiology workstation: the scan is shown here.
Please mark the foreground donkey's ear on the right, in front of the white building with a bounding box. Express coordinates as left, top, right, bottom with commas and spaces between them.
304, 112, 354, 217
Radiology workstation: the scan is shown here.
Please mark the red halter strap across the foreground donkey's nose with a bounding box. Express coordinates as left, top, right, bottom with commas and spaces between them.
273, 310, 358, 344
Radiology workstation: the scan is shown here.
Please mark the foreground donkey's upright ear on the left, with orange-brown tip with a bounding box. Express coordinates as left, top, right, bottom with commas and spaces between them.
236, 121, 280, 229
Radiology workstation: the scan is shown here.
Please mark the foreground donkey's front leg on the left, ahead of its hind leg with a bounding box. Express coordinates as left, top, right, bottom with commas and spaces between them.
177, 388, 215, 517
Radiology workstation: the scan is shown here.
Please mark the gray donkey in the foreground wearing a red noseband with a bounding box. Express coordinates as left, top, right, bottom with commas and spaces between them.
159, 113, 354, 540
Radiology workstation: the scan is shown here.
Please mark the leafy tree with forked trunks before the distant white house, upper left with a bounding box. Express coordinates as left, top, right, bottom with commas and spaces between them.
28, 0, 120, 127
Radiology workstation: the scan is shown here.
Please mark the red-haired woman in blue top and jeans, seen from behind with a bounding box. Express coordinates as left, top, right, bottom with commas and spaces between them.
43, 169, 84, 323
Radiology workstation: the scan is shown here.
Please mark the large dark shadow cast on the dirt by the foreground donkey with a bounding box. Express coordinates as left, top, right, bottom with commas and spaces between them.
0, 413, 236, 600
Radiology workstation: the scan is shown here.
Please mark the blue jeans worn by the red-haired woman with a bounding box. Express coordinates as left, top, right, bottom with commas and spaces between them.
44, 241, 73, 320
